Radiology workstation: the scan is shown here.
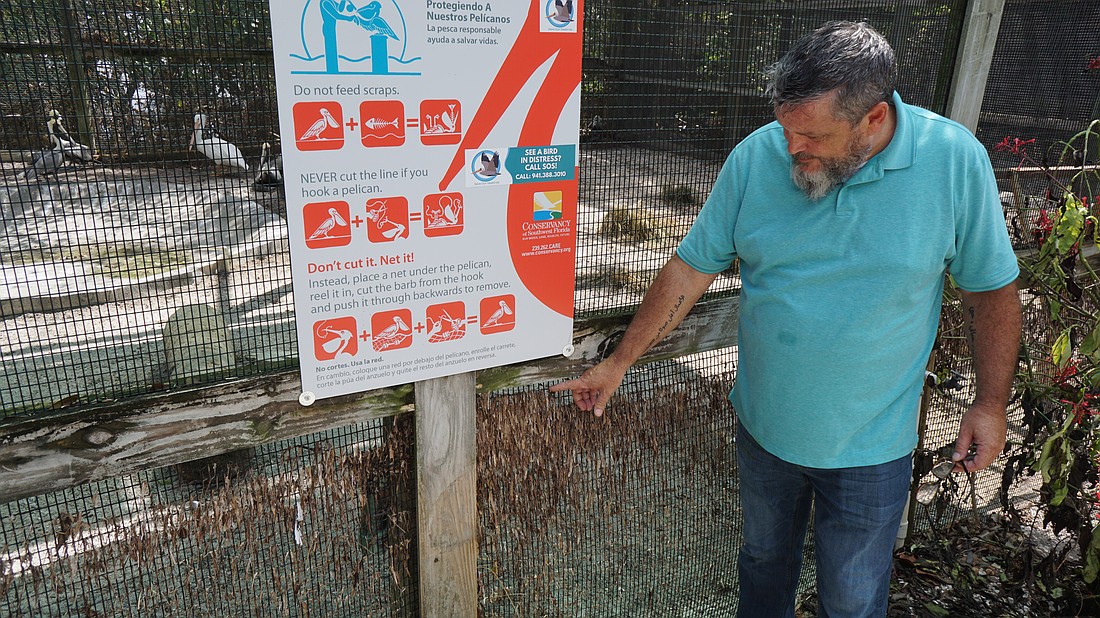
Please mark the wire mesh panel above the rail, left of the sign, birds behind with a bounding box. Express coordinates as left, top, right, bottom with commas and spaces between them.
0, 0, 296, 416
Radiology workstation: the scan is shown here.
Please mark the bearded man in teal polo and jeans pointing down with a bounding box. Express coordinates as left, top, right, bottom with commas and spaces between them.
551, 22, 1020, 617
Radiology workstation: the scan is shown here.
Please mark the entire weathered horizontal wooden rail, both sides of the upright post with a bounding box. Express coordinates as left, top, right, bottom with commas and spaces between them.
0, 297, 737, 503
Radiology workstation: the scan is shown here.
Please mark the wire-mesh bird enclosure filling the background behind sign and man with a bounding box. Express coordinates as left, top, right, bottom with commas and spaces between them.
0, 0, 1100, 617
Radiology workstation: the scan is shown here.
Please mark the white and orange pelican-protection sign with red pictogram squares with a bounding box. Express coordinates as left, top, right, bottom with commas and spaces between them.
271, 0, 582, 404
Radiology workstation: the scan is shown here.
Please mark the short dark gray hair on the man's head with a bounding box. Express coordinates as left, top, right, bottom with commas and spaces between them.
766, 21, 898, 124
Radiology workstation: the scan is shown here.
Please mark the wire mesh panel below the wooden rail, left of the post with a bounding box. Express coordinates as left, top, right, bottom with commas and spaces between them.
0, 419, 417, 617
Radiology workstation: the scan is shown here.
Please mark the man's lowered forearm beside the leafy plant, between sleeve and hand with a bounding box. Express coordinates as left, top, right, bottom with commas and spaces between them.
963, 283, 1021, 408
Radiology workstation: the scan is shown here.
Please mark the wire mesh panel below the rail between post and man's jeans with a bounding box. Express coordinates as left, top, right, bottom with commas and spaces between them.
477, 350, 740, 616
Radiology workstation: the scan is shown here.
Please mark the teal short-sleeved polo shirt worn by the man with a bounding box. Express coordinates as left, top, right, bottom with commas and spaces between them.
677, 93, 1020, 468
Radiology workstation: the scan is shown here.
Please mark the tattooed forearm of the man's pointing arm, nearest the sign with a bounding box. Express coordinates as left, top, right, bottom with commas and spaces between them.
612, 255, 717, 367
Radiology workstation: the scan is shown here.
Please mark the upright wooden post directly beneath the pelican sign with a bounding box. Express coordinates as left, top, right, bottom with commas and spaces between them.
416, 373, 480, 618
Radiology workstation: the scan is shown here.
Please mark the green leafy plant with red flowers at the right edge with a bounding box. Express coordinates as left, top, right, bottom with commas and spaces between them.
994, 121, 1100, 588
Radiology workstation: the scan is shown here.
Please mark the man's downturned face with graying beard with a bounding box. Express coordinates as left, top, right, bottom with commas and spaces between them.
776, 96, 871, 200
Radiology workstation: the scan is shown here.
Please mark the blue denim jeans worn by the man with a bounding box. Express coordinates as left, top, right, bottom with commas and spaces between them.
737, 424, 913, 618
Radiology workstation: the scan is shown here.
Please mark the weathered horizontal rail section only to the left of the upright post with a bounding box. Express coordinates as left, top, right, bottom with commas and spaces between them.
0, 372, 413, 503
